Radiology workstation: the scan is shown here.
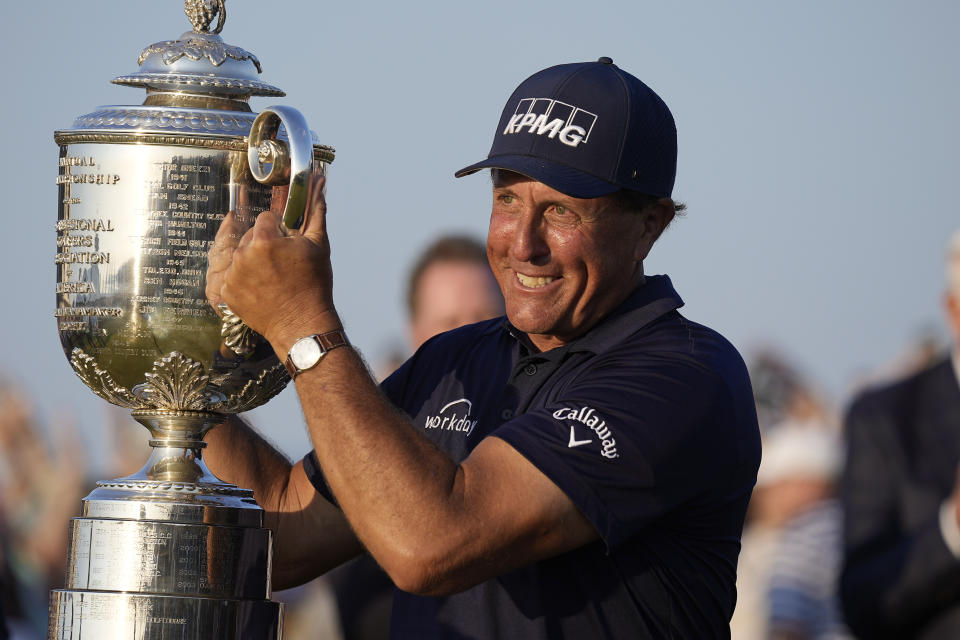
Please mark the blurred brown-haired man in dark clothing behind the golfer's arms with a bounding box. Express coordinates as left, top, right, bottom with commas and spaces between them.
310, 235, 504, 640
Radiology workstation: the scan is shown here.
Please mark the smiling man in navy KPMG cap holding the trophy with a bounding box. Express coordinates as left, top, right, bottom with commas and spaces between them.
209, 58, 759, 638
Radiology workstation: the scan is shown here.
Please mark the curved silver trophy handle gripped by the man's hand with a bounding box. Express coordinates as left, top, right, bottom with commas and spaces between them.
247, 105, 313, 229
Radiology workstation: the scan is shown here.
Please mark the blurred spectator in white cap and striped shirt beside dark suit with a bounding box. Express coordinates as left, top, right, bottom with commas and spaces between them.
731, 352, 849, 640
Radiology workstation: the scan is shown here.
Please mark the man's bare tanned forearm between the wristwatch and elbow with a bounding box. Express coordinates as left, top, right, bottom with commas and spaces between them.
288, 349, 458, 579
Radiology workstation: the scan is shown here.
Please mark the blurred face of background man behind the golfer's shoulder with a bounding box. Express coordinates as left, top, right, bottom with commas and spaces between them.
410, 260, 503, 349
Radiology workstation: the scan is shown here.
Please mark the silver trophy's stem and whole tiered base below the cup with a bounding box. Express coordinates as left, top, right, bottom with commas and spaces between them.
47, 413, 283, 640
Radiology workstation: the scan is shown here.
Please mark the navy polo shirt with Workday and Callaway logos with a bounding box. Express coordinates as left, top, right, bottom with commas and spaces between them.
304, 276, 760, 640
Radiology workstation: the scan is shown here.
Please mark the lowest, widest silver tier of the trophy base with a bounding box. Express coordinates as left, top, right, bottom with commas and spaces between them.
47, 589, 283, 640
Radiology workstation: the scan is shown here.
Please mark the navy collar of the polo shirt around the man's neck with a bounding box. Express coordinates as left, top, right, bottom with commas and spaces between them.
503, 275, 683, 355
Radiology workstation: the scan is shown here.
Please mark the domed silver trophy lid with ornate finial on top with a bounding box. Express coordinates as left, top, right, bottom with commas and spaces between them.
113, 0, 286, 108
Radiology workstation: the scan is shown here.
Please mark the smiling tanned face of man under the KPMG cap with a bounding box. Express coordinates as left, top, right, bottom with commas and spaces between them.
487, 171, 669, 351
